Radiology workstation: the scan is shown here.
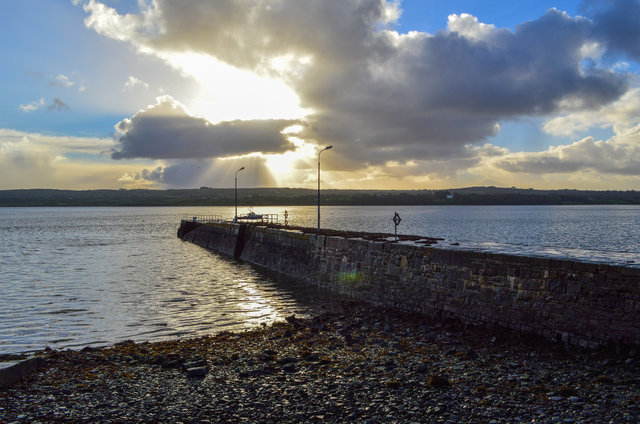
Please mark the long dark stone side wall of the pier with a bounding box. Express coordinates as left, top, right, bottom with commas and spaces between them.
181, 222, 640, 347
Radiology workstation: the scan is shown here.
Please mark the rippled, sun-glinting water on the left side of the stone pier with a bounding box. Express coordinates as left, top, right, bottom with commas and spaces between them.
0, 208, 340, 353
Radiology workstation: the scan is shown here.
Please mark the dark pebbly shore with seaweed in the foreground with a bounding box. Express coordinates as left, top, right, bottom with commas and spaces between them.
0, 305, 640, 424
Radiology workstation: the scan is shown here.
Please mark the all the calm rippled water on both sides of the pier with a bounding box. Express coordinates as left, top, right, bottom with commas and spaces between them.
0, 206, 640, 353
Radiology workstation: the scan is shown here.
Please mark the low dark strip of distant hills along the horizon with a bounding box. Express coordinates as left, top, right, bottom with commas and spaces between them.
0, 187, 640, 207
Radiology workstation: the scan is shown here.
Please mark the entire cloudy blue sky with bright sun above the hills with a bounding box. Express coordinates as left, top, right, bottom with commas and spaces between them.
0, 0, 640, 190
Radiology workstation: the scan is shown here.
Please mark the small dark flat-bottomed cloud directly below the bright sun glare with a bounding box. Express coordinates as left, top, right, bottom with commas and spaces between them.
111, 96, 292, 159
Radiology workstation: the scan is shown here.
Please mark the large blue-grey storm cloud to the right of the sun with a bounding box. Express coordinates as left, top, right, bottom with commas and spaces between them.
297, 10, 628, 166
